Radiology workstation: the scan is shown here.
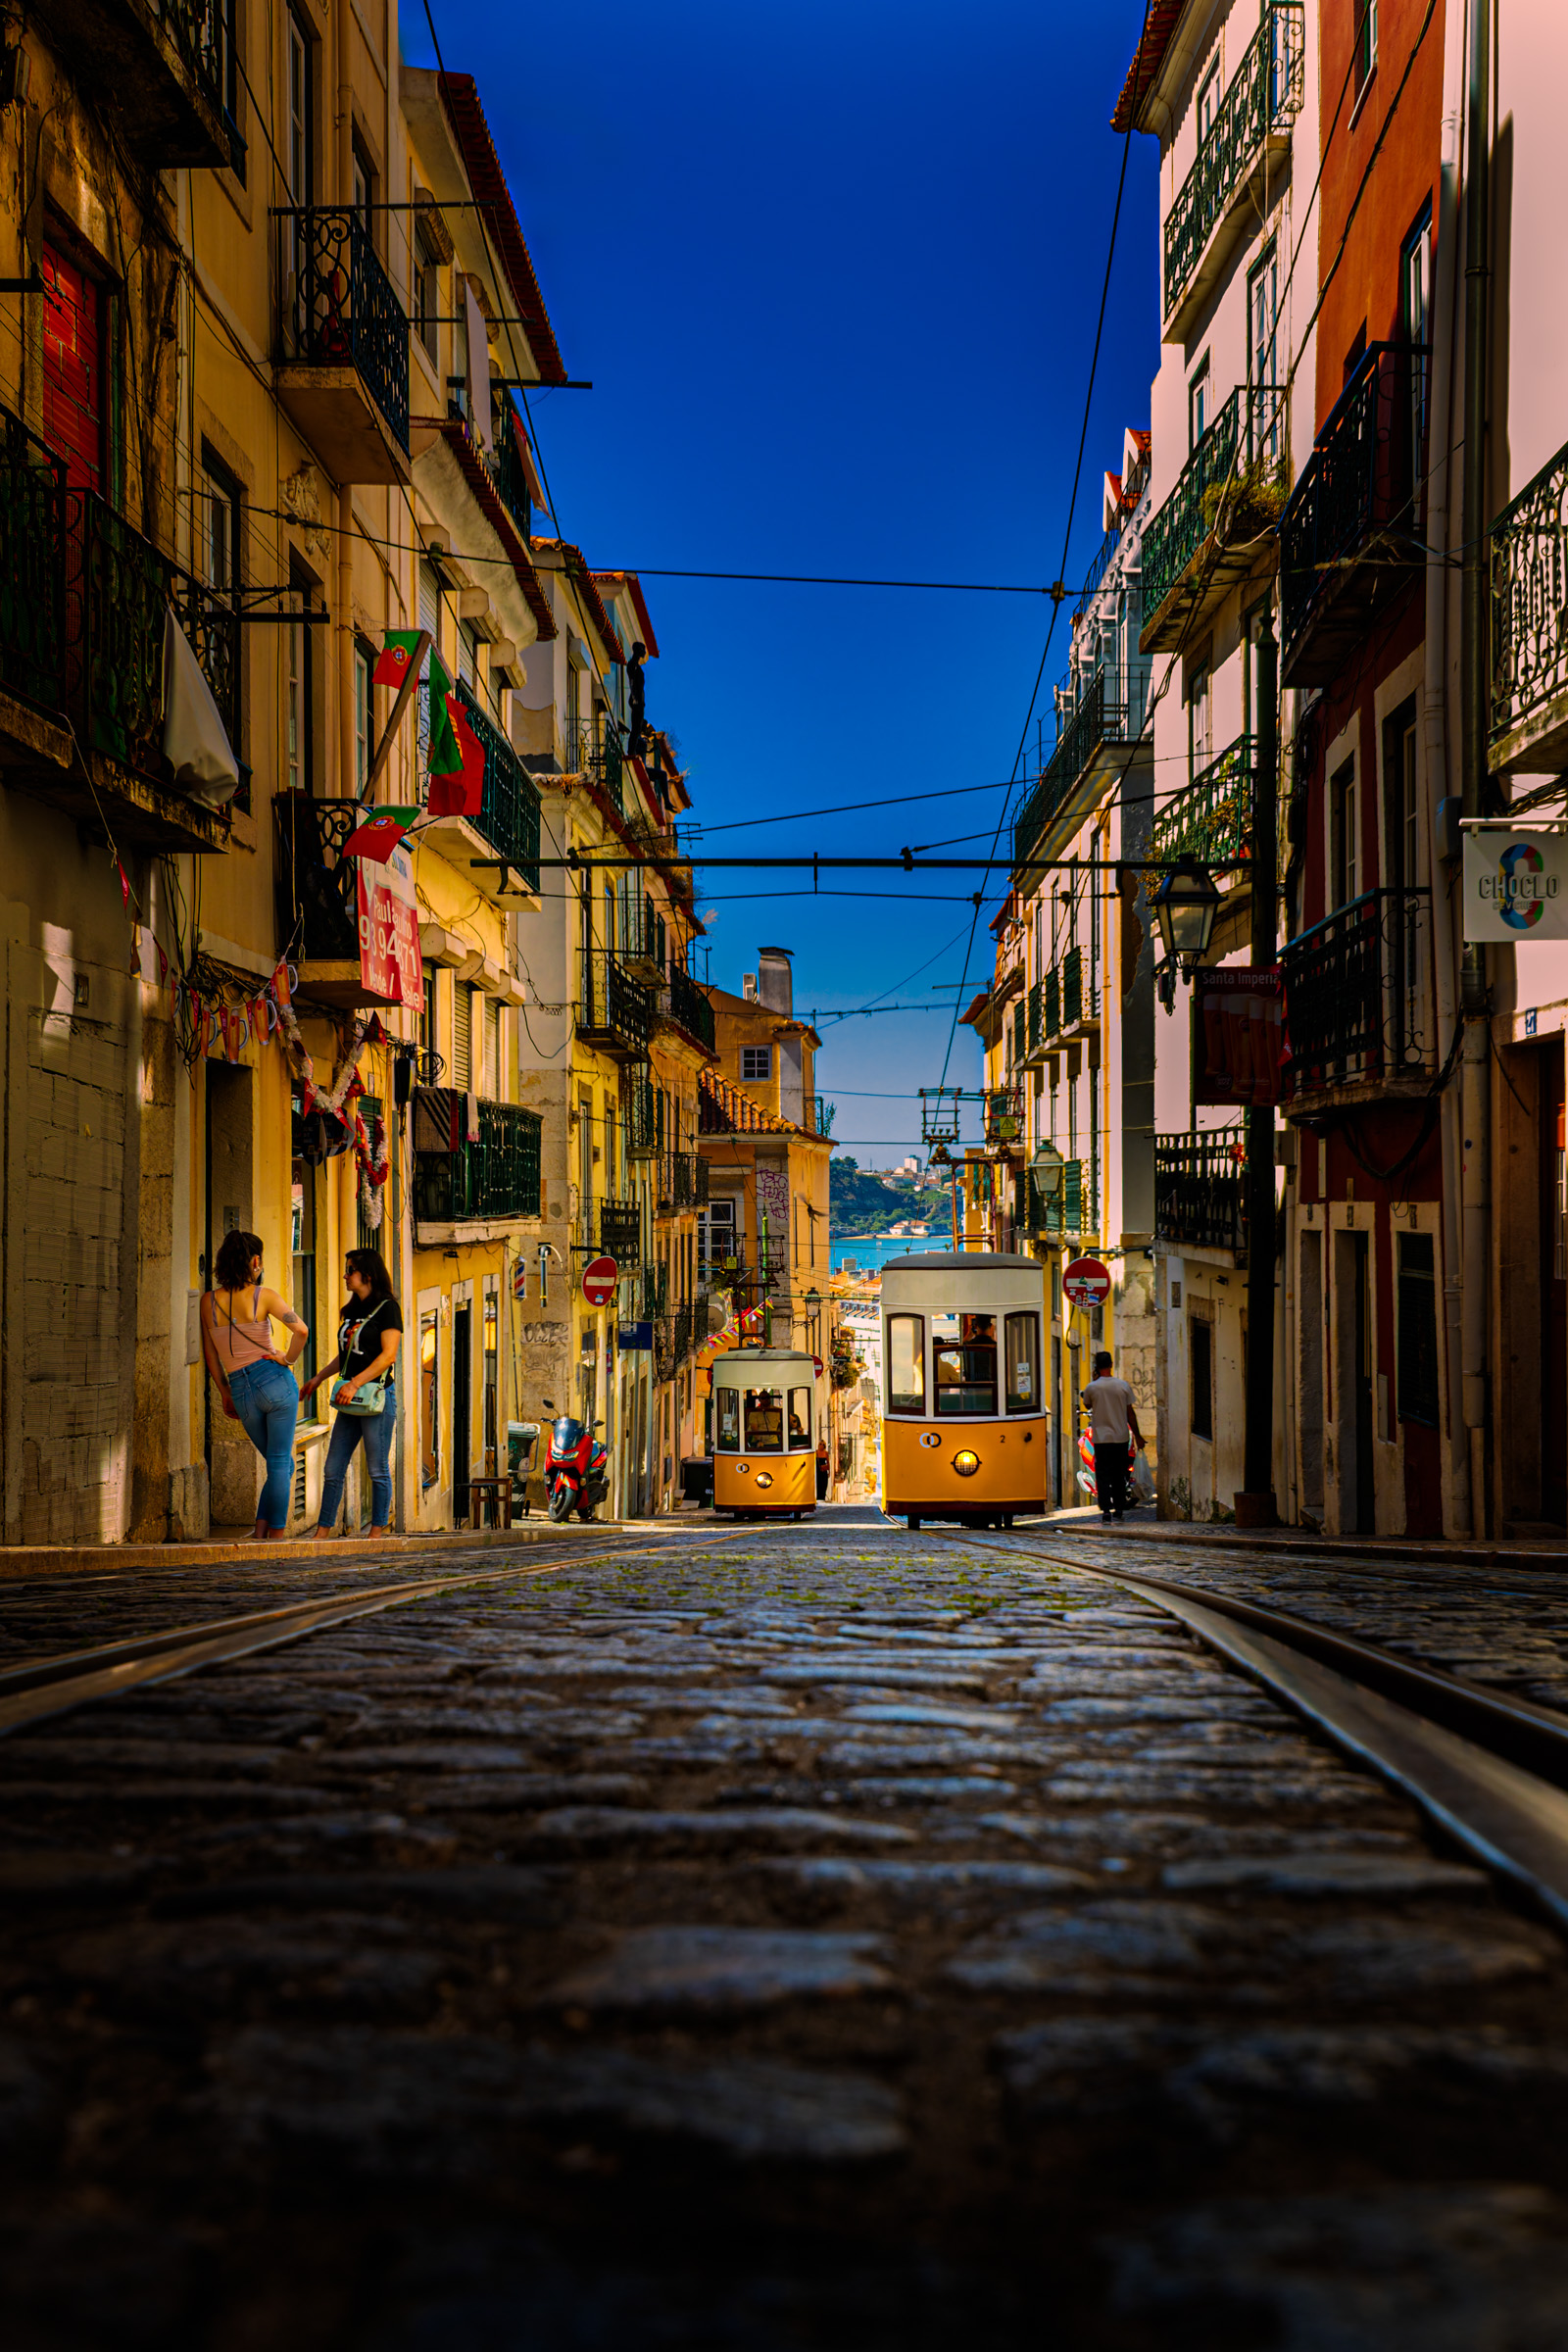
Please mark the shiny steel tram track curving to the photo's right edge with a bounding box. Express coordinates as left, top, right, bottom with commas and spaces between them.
945, 1534, 1568, 1931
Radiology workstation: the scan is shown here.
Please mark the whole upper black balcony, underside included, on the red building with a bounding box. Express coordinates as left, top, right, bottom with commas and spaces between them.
1279, 343, 1427, 687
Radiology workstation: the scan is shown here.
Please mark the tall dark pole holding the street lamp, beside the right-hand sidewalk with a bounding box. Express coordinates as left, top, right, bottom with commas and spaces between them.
1237, 605, 1279, 1527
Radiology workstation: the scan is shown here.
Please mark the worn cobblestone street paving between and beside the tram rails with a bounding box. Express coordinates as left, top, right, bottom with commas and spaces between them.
0, 1510, 1568, 2352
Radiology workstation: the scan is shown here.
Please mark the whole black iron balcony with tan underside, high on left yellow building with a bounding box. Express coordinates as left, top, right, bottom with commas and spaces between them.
277, 205, 409, 482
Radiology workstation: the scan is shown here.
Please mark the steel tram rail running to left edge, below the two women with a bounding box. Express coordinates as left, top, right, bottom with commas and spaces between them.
0, 1531, 738, 1734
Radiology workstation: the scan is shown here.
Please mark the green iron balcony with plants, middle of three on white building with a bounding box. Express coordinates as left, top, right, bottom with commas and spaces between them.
1138, 383, 1286, 654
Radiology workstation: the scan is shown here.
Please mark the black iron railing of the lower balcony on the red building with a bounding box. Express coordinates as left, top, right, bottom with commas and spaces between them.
1279, 889, 1434, 1101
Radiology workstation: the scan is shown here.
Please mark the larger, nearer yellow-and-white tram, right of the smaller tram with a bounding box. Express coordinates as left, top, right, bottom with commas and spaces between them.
882, 1249, 1049, 1527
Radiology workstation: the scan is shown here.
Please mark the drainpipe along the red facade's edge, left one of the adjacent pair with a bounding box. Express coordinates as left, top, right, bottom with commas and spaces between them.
1422, 23, 1472, 1536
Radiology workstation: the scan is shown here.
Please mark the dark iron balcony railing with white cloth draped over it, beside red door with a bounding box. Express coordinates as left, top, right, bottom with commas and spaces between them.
66, 489, 240, 783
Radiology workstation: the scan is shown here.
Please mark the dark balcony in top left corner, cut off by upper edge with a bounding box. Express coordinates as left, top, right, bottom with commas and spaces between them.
35, 0, 232, 170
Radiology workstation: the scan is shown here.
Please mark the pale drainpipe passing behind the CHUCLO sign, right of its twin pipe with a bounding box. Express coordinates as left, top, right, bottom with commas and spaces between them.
1460, 0, 1493, 1536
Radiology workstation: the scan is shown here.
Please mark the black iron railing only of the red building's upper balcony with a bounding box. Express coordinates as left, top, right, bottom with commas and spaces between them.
1279, 343, 1427, 659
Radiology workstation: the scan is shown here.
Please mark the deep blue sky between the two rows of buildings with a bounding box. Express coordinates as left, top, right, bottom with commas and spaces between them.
402, 0, 1159, 1166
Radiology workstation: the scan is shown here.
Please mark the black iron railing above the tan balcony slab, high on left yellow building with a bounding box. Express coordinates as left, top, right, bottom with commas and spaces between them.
277, 205, 409, 457
